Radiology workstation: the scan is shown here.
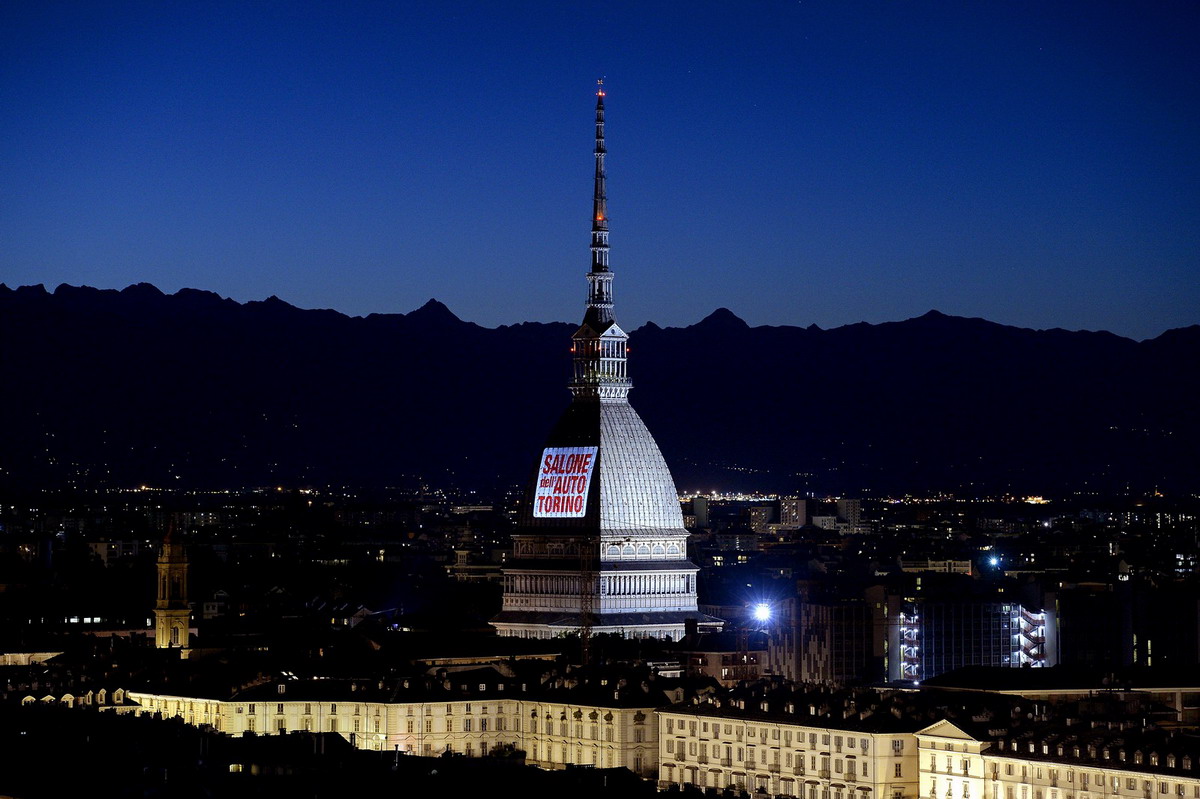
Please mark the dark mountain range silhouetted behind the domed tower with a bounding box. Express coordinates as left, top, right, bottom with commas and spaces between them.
0, 283, 1200, 494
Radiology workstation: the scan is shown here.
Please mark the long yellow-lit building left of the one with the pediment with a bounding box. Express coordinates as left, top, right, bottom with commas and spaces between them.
104, 674, 662, 777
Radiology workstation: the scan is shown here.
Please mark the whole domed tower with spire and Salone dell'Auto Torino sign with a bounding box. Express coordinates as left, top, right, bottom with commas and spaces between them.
492, 85, 720, 638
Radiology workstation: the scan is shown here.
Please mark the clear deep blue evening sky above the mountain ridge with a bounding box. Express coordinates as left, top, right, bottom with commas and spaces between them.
0, 0, 1200, 338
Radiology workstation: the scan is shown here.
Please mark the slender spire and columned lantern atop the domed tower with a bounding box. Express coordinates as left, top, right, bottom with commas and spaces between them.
571, 79, 631, 400
